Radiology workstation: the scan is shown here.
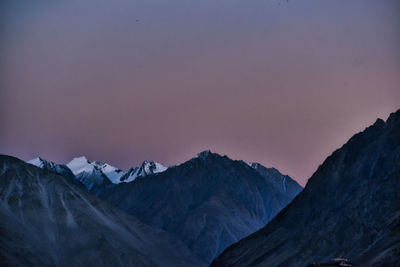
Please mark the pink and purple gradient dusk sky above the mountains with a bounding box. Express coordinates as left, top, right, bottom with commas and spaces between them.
0, 0, 400, 185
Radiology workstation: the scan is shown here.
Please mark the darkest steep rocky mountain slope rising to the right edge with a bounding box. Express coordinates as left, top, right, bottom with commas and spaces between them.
211, 110, 400, 267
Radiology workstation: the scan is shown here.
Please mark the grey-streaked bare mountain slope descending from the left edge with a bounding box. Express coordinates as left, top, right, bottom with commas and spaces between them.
0, 156, 204, 266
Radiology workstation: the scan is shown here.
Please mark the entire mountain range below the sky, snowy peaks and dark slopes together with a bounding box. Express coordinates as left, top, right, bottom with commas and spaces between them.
0, 111, 400, 267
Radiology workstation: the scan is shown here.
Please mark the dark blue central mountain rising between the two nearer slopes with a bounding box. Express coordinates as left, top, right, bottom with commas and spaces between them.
26, 151, 302, 263
